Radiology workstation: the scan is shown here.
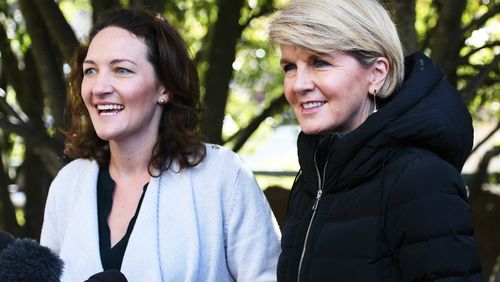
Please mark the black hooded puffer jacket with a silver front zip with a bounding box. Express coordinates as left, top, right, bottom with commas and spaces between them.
278, 53, 481, 282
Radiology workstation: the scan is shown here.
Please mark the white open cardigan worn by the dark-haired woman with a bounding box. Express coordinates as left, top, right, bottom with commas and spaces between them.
41, 144, 280, 282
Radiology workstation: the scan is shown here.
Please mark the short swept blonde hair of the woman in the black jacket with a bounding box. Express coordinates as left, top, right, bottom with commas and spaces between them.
269, 0, 404, 98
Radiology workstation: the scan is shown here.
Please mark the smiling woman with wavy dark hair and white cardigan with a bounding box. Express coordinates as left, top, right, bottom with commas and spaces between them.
41, 9, 280, 281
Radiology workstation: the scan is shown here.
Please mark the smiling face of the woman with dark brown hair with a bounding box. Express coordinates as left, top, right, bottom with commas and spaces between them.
81, 26, 168, 148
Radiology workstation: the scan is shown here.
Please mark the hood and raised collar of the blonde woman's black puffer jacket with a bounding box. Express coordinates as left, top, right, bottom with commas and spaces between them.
297, 53, 472, 193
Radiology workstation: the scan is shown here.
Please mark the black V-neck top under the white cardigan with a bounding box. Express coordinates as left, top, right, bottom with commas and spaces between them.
97, 167, 148, 270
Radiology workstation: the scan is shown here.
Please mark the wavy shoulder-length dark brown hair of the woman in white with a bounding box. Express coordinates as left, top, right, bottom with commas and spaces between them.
64, 8, 206, 175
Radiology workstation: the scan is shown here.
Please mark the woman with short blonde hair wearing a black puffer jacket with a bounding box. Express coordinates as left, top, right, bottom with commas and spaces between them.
269, 0, 481, 282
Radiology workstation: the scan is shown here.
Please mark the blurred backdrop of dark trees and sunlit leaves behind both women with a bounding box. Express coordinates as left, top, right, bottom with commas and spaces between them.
0, 0, 500, 275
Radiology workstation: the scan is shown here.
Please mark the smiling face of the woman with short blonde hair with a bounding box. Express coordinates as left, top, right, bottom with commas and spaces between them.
281, 44, 378, 134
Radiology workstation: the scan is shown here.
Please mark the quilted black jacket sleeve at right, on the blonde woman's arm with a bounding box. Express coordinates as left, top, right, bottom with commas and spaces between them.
386, 154, 481, 281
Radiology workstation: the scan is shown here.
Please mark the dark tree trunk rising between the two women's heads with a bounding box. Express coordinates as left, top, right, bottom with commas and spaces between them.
202, 0, 244, 144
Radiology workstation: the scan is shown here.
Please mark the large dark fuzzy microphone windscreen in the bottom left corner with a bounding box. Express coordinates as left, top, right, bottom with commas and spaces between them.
0, 239, 63, 282
